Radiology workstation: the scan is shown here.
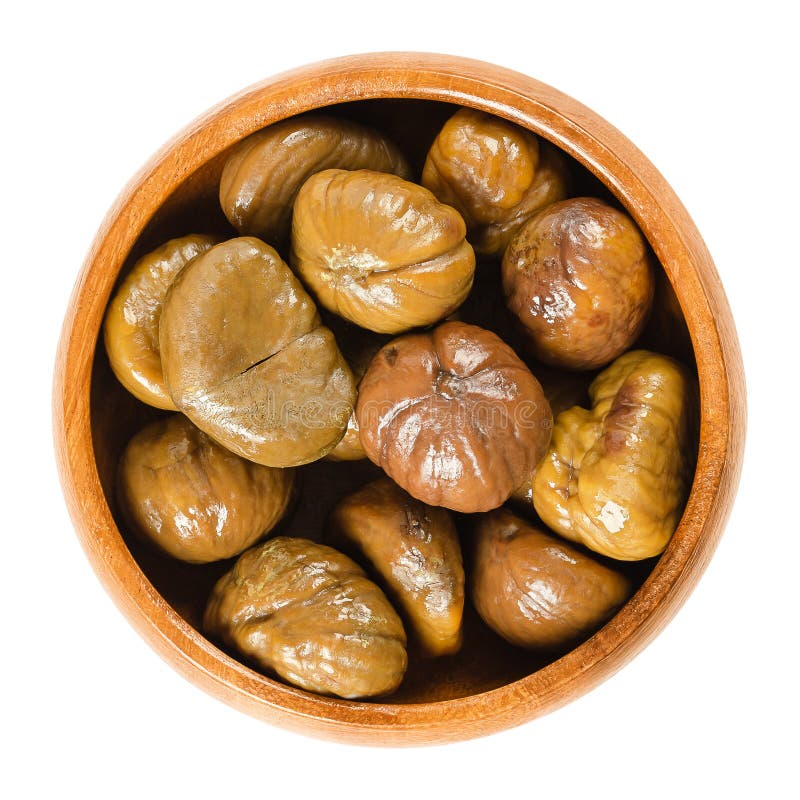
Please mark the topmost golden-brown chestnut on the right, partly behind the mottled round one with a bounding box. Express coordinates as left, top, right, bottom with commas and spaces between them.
422, 108, 567, 255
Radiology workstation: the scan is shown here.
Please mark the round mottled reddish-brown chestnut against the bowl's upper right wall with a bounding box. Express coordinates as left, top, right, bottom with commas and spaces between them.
502, 197, 653, 370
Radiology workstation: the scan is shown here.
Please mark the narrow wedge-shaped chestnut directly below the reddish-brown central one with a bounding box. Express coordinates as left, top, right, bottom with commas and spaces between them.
326, 478, 464, 656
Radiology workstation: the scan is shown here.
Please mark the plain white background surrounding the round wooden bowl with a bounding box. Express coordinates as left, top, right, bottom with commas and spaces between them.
0, 0, 800, 798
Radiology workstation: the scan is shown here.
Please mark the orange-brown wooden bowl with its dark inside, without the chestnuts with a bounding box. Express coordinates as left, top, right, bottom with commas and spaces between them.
54, 53, 745, 744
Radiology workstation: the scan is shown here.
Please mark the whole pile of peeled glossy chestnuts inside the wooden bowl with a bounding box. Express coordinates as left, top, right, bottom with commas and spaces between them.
103, 109, 697, 698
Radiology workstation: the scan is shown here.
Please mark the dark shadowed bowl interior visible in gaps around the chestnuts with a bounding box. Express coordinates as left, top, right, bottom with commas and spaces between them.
90, 99, 695, 704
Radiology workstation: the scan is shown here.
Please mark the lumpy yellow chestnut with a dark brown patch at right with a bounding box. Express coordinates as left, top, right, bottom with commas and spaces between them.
533, 350, 697, 561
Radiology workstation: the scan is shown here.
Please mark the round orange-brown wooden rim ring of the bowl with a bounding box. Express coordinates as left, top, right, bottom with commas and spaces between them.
53, 52, 746, 745
